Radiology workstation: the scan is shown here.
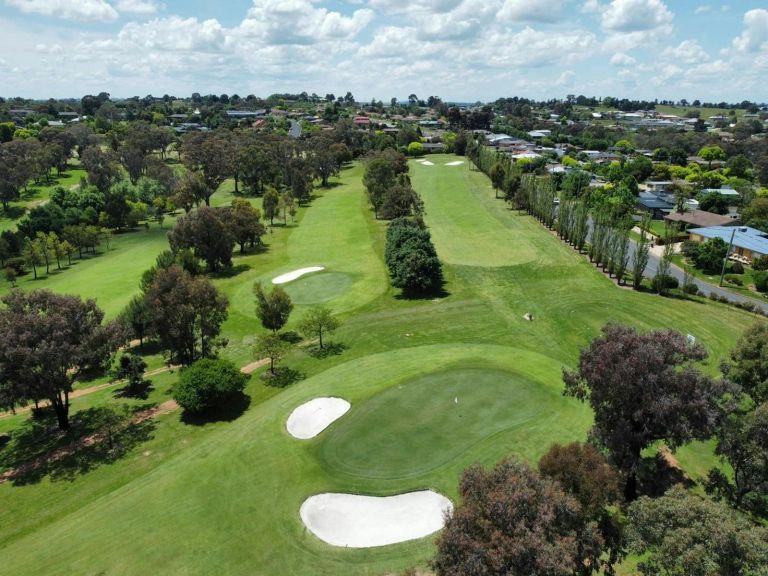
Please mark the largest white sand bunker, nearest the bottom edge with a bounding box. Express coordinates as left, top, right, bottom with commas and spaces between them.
299, 490, 453, 548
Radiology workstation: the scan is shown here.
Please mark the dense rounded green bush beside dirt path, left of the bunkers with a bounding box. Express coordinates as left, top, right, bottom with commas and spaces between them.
173, 358, 248, 413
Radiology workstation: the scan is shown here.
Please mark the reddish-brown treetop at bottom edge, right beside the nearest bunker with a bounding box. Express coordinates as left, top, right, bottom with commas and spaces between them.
433, 460, 602, 576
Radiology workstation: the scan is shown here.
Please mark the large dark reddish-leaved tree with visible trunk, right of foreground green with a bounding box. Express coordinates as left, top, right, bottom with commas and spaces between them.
563, 324, 722, 501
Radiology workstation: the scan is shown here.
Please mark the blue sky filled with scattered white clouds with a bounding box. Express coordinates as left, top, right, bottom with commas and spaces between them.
0, 0, 768, 101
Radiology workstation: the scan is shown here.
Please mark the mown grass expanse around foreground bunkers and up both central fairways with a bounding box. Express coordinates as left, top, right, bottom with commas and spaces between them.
0, 156, 755, 575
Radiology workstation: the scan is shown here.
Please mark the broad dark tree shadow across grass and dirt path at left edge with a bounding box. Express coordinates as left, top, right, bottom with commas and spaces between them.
0, 406, 155, 486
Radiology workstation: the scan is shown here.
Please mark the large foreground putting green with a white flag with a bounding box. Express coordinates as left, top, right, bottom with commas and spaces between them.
319, 367, 562, 479
